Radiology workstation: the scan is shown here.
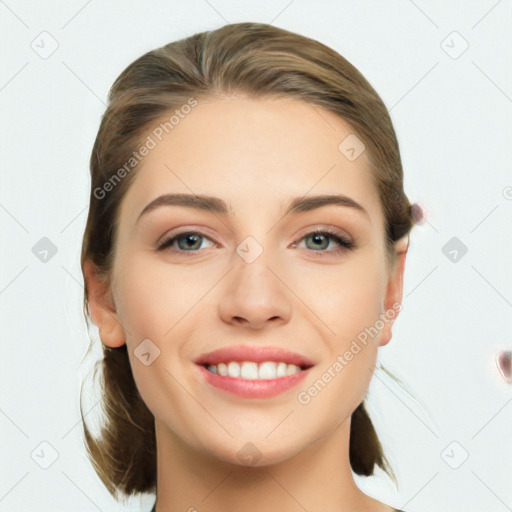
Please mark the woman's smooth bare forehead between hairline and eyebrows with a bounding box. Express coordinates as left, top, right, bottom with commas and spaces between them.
116, 97, 380, 228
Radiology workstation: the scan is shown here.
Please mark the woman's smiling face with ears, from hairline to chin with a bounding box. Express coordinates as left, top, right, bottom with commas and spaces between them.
91, 97, 405, 465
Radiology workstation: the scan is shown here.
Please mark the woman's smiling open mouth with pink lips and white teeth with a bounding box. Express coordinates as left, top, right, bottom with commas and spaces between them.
195, 345, 314, 398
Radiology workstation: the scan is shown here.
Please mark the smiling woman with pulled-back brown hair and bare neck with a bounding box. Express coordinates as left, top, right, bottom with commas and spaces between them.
81, 23, 413, 512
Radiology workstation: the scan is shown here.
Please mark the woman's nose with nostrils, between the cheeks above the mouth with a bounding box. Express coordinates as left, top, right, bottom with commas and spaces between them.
218, 251, 292, 329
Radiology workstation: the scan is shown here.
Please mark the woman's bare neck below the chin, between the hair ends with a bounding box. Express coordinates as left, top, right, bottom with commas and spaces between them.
155, 418, 391, 512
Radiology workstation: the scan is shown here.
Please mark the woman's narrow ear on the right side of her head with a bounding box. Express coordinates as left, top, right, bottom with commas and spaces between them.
379, 237, 409, 346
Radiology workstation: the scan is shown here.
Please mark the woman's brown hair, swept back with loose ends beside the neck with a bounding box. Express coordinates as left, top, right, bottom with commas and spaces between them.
80, 23, 414, 499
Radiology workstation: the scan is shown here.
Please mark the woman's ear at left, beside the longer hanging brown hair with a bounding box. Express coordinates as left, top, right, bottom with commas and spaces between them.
84, 260, 126, 348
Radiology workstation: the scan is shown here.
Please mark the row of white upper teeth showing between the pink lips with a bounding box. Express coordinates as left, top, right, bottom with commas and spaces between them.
207, 361, 302, 380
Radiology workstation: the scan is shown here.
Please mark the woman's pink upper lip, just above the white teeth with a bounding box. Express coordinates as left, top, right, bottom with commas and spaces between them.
195, 345, 315, 367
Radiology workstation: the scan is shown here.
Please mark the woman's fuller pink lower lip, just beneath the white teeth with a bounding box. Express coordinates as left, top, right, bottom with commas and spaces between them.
198, 365, 311, 398
